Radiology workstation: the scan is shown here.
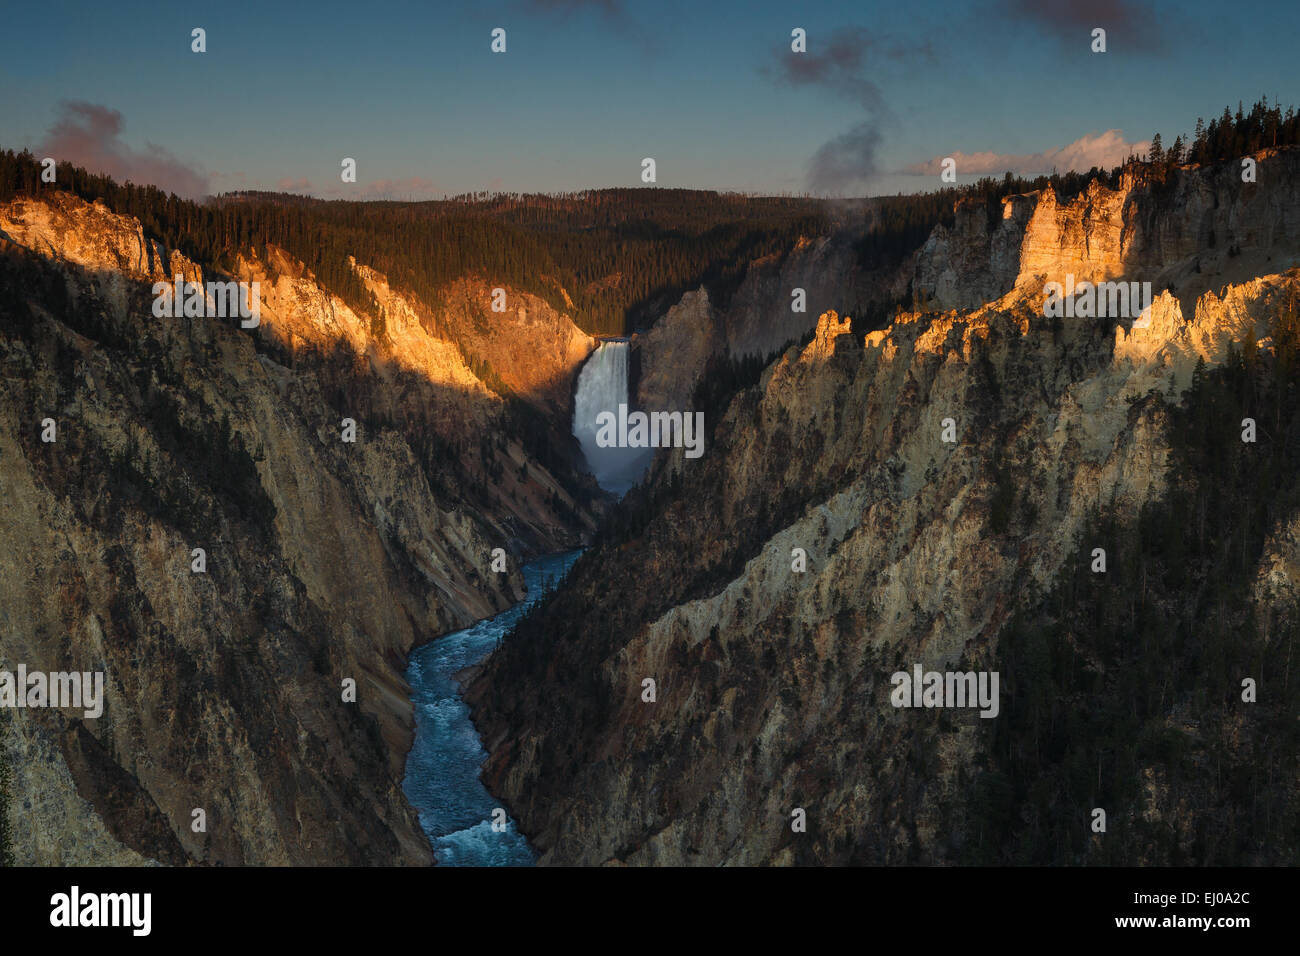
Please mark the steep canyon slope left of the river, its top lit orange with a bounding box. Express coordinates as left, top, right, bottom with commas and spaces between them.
0, 193, 595, 864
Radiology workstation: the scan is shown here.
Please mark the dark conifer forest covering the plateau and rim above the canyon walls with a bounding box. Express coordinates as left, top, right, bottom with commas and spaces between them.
0, 100, 1300, 334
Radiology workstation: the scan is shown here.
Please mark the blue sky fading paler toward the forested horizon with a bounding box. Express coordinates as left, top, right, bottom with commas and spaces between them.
0, 0, 1300, 198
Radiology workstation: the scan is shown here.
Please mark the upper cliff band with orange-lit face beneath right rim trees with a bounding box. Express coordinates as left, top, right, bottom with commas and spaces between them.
914, 147, 1300, 312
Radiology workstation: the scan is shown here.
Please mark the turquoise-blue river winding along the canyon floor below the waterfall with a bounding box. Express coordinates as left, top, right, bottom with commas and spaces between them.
403, 550, 582, 866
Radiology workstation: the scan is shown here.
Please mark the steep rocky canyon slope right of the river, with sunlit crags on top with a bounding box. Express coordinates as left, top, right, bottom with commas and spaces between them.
467, 148, 1300, 864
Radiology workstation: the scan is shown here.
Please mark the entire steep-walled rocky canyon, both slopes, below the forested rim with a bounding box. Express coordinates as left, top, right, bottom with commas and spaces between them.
0, 147, 1300, 865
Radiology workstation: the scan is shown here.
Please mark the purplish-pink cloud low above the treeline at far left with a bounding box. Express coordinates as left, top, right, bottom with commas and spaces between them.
36, 100, 212, 199
